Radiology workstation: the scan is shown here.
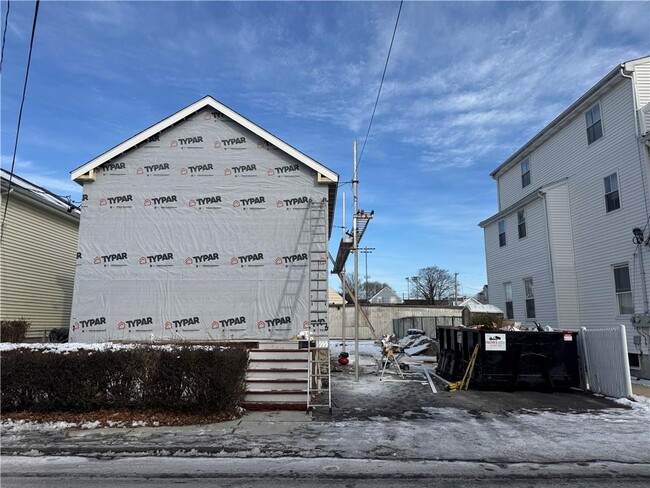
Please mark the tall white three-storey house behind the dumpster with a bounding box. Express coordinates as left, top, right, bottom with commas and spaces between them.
480, 57, 650, 378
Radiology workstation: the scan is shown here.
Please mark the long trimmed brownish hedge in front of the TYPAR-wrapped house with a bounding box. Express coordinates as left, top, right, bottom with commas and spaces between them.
0, 346, 248, 413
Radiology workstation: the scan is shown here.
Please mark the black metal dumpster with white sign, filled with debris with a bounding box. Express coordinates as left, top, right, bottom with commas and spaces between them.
436, 326, 580, 391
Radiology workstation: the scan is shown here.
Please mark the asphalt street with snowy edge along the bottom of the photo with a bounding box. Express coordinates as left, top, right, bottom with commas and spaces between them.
1, 456, 650, 488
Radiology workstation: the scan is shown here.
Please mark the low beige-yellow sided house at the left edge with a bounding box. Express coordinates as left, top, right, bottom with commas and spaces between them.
0, 169, 79, 341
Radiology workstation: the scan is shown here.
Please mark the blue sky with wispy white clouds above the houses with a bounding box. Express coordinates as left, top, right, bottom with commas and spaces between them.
1, 1, 650, 295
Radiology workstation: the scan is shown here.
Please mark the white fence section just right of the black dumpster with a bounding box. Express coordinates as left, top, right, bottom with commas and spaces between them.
578, 325, 632, 398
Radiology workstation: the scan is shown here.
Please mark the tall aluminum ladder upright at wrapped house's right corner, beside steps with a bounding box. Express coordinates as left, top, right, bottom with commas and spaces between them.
307, 198, 332, 414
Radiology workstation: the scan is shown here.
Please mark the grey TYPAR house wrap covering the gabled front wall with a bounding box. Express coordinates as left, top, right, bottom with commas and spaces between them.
70, 109, 328, 342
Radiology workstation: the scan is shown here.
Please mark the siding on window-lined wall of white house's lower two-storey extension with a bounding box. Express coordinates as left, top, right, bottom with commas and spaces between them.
485, 198, 557, 326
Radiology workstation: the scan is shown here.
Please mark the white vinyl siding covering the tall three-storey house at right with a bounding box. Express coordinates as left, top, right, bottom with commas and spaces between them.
484, 62, 650, 358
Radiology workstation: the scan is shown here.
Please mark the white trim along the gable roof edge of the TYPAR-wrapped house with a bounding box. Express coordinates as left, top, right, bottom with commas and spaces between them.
70, 96, 339, 183
